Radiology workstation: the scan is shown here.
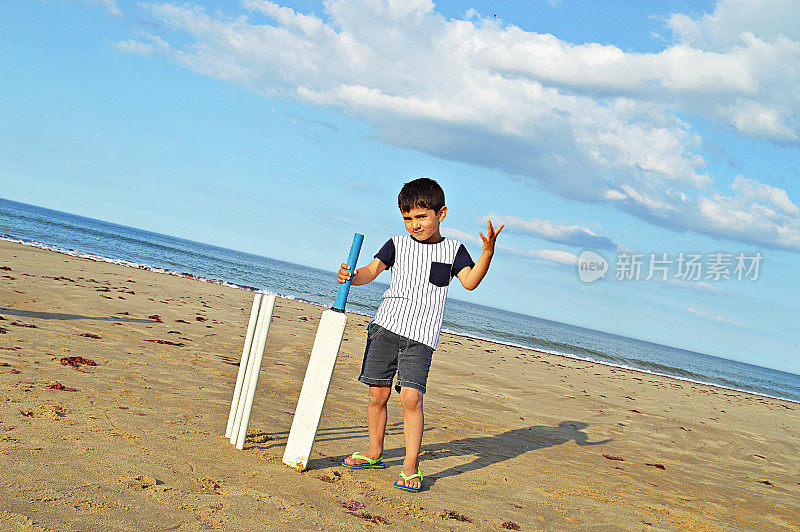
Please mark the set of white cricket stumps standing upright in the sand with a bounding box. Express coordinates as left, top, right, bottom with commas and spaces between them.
225, 293, 275, 450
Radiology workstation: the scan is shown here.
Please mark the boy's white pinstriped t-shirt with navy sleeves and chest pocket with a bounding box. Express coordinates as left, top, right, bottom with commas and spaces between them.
372, 235, 475, 349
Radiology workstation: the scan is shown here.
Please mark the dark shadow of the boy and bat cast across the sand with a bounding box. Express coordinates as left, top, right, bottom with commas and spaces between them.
308, 421, 612, 482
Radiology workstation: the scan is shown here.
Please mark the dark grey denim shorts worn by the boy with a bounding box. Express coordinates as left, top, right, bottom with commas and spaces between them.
358, 323, 433, 393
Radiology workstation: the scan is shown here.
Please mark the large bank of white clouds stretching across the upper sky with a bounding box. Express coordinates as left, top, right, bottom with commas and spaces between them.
123, 0, 800, 251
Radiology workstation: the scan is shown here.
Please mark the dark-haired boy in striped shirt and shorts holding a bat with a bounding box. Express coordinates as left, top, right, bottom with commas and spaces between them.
338, 178, 503, 492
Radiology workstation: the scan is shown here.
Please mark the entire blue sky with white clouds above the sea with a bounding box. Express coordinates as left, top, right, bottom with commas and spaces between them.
0, 0, 800, 372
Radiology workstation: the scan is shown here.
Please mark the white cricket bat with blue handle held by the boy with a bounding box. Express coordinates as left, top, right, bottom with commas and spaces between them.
283, 233, 364, 471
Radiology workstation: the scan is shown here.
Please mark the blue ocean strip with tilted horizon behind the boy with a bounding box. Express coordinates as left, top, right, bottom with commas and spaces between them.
0, 198, 800, 402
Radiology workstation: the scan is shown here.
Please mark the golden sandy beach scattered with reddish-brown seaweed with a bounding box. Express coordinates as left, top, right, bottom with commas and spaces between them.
0, 241, 800, 530
